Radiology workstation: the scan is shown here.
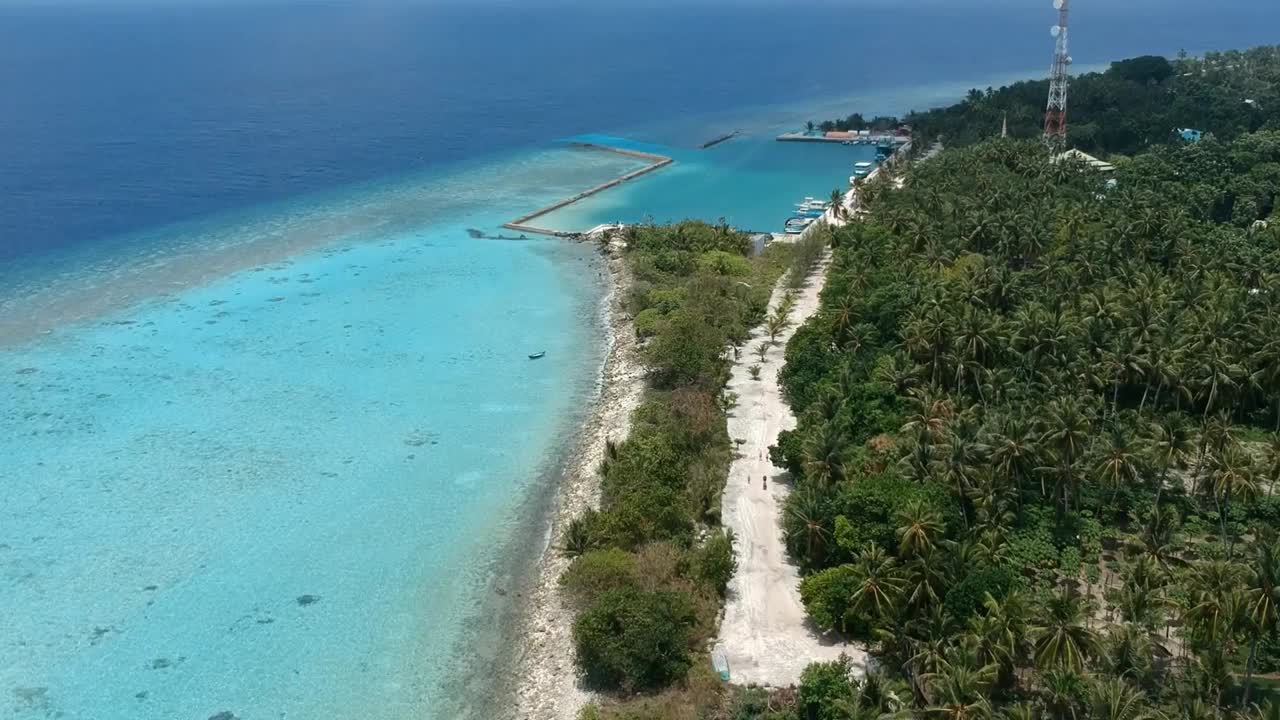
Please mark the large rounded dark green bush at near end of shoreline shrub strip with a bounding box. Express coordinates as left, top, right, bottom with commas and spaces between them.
573, 589, 696, 692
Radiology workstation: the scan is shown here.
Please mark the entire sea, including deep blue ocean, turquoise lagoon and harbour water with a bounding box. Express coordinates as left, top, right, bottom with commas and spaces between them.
0, 0, 1280, 720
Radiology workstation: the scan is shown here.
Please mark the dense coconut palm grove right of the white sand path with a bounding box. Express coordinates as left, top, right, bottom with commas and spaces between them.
731, 114, 1280, 720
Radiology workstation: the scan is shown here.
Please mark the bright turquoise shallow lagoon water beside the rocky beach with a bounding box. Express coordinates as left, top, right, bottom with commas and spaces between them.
0, 150, 631, 719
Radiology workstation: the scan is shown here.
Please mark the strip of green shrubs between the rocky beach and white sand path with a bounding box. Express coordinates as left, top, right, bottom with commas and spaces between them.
562, 222, 827, 717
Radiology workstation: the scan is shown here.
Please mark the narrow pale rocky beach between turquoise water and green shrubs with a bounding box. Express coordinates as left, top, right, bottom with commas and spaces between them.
507, 237, 645, 720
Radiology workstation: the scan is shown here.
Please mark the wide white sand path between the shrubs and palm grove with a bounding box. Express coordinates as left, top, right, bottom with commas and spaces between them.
718, 235, 865, 687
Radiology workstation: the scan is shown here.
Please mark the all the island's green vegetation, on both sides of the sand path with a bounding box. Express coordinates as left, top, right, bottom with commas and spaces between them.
563, 47, 1280, 720
